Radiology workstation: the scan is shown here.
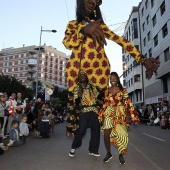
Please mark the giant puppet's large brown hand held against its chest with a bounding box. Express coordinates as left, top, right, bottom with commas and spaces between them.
84, 19, 107, 45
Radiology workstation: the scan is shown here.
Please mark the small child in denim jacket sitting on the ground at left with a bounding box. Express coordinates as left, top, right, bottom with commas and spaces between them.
7, 120, 23, 146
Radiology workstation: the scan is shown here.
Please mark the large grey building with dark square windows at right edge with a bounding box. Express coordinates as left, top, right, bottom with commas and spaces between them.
139, 0, 170, 104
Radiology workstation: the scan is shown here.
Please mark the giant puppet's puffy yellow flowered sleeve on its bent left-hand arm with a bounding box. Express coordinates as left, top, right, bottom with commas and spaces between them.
63, 21, 85, 50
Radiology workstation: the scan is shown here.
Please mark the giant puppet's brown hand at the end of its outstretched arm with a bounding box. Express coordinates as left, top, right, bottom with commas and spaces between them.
143, 58, 160, 80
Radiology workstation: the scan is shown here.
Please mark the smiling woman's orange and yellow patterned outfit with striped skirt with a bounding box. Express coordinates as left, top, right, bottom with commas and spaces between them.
99, 89, 139, 154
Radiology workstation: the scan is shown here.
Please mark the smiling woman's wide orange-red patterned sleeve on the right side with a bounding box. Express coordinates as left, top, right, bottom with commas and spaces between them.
123, 89, 139, 124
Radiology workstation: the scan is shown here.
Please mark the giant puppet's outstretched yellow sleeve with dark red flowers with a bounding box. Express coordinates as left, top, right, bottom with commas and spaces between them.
101, 24, 142, 63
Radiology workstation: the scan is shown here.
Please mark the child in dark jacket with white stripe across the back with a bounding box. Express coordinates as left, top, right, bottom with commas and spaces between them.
39, 110, 52, 138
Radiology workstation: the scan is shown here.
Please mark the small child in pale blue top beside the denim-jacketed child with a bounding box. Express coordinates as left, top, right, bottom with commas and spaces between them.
19, 114, 29, 144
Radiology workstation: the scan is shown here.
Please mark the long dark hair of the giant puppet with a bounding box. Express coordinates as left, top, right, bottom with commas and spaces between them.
76, 0, 104, 23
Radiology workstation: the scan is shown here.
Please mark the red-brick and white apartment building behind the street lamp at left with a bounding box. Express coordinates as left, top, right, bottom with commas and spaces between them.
0, 45, 68, 88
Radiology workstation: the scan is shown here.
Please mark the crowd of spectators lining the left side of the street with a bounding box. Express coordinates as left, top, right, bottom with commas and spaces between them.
0, 92, 66, 154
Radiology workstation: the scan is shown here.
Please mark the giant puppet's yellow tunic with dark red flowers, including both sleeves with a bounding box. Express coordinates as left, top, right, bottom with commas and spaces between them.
63, 20, 142, 91
